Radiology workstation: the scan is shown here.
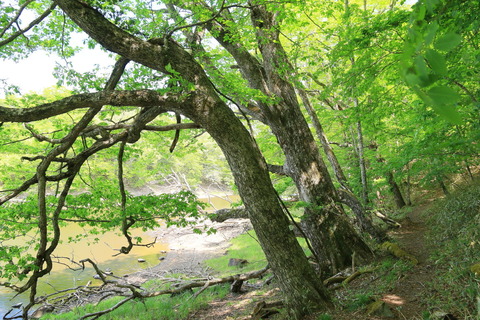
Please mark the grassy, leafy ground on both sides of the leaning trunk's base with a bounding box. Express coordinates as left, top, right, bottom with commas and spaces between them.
38, 183, 480, 320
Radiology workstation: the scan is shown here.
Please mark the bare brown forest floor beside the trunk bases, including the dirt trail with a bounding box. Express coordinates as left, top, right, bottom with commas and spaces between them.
181, 201, 446, 320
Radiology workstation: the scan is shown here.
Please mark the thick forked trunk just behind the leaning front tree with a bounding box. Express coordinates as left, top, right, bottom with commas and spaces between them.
201, 3, 372, 274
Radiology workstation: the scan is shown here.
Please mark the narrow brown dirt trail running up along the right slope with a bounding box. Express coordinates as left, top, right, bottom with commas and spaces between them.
382, 203, 434, 319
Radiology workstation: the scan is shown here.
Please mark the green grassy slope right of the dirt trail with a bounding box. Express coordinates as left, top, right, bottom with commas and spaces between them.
428, 180, 480, 319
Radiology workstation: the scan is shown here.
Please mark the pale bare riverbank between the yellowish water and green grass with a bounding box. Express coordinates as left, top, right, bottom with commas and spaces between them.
26, 219, 252, 314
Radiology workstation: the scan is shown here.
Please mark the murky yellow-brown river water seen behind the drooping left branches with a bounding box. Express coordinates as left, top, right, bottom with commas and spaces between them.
0, 196, 238, 317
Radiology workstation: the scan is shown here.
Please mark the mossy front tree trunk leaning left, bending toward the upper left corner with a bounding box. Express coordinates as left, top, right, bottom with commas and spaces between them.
50, 0, 329, 319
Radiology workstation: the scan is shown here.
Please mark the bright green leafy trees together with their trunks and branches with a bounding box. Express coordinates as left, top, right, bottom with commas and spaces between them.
0, 0, 480, 318
